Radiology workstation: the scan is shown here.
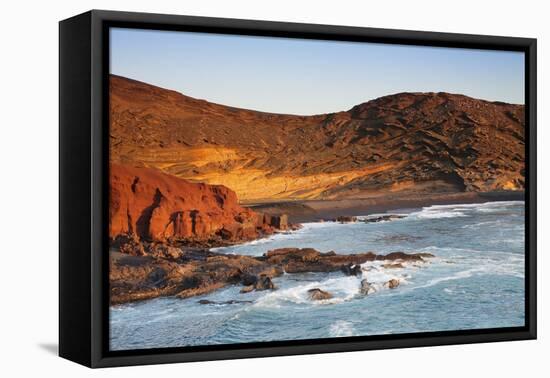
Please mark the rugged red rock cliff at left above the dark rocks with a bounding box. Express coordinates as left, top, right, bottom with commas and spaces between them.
109, 164, 286, 241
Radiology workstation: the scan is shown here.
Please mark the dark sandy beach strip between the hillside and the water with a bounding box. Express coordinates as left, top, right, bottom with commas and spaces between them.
247, 191, 525, 223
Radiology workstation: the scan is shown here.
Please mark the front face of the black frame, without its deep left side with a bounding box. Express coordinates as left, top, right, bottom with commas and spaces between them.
80, 10, 537, 367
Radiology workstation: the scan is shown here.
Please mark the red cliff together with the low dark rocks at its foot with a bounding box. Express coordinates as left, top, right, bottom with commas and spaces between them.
109, 159, 438, 304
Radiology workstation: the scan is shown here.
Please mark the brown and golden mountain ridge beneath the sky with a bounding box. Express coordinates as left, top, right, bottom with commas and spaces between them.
110, 75, 525, 202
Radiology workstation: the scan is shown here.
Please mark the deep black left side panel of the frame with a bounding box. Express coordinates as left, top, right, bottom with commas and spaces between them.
59, 12, 93, 366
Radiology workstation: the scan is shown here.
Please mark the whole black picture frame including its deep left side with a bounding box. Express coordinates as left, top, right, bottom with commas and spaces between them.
59, 10, 537, 367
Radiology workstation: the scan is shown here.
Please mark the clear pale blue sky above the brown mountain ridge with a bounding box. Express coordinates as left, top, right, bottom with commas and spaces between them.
110, 28, 524, 115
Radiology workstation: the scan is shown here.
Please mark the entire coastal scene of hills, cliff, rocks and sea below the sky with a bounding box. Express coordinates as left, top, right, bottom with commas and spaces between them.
108, 74, 526, 351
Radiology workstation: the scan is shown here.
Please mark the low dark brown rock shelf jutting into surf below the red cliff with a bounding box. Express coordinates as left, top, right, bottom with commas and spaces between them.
109, 248, 431, 304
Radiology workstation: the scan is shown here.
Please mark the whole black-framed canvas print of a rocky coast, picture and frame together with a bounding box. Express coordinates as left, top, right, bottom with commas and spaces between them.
59, 11, 536, 367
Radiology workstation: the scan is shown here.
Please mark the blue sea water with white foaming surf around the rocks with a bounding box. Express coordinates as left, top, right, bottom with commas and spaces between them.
110, 201, 525, 350
